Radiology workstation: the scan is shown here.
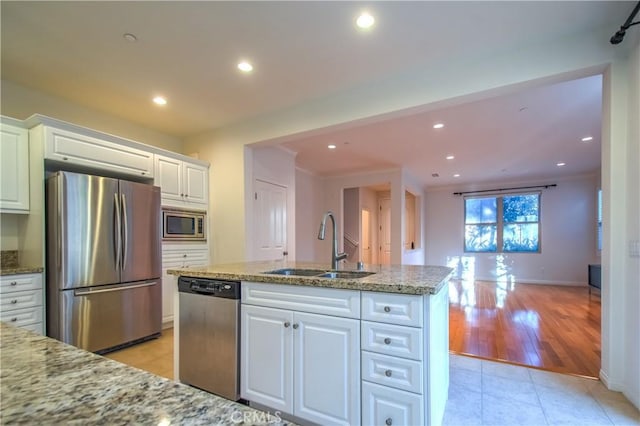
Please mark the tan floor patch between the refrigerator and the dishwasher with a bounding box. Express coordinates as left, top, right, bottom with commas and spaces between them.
105, 328, 173, 380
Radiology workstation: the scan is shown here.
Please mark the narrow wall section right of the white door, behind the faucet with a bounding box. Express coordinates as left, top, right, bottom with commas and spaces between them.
296, 169, 324, 262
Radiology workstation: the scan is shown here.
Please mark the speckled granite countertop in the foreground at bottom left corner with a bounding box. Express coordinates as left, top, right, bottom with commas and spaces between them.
0, 323, 290, 426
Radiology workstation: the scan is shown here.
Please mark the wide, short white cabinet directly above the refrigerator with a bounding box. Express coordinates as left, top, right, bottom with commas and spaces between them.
44, 126, 153, 178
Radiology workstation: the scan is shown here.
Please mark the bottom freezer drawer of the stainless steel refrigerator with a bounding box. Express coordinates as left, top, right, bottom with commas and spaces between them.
58, 281, 162, 352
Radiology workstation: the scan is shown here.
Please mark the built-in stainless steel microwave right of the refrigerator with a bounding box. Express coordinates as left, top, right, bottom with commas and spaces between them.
162, 208, 207, 241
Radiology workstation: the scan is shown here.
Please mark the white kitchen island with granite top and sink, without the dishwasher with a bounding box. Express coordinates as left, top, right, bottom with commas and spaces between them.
167, 261, 452, 425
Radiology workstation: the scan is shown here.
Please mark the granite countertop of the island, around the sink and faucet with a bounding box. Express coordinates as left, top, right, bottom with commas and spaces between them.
167, 261, 453, 294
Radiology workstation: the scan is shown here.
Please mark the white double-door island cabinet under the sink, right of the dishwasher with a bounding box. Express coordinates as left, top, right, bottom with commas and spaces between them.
240, 282, 360, 425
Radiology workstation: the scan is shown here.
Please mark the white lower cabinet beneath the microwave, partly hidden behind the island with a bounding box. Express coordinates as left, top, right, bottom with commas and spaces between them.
162, 244, 209, 324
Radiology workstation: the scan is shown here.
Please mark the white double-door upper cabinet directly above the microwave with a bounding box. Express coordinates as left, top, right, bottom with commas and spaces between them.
154, 155, 209, 209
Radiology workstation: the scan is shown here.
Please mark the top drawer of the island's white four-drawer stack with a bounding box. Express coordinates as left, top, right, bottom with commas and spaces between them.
362, 292, 423, 327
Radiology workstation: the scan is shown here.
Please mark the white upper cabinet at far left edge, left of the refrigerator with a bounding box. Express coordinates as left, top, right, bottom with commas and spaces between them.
0, 118, 29, 213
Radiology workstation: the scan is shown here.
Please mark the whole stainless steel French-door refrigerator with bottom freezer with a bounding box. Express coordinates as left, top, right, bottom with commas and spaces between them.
46, 171, 162, 352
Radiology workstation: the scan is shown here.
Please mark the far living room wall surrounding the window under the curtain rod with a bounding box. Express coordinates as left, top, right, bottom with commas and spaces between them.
425, 176, 599, 285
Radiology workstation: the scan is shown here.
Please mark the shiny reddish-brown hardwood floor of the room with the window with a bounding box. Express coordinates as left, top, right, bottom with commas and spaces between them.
449, 281, 601, 377
